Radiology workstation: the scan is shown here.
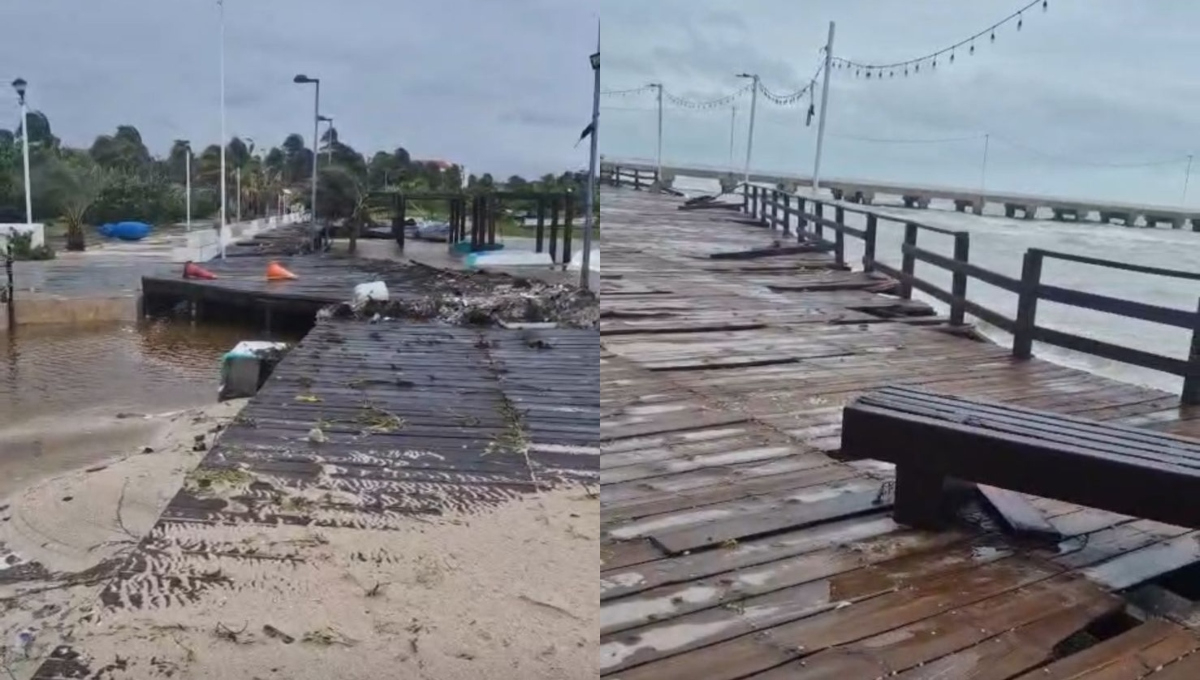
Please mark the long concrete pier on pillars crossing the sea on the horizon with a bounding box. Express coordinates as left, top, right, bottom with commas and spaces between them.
600, 158, 1200, 231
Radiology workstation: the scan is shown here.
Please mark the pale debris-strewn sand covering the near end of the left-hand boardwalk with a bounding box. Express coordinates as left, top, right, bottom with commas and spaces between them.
0, 402, 600, 680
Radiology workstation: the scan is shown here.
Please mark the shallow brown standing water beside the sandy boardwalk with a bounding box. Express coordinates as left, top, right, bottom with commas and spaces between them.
0, 321, 298, 498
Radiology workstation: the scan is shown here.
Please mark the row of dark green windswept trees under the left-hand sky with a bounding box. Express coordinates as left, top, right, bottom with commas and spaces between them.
0, 112, 578, 249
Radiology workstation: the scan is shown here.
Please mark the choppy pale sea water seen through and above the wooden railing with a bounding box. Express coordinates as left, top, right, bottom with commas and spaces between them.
676, 177, 1200, 392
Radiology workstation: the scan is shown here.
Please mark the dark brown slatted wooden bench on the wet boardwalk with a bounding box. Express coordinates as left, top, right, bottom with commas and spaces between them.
841, 387, 1200, 528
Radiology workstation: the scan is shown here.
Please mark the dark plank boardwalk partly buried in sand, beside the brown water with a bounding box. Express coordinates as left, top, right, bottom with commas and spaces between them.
36, 319, 599, 680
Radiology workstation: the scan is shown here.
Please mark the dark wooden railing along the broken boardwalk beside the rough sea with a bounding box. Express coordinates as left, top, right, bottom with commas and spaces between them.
742, 185, 1200, 404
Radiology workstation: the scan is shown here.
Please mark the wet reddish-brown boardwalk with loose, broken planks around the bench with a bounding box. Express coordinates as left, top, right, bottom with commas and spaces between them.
600, 188, 1200, 680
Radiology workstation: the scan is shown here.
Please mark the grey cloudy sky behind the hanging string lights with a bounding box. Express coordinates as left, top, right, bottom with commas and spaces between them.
600, 0, 1200, 205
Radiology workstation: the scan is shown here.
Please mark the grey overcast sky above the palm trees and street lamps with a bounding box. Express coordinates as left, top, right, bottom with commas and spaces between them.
0, 0, 596, 176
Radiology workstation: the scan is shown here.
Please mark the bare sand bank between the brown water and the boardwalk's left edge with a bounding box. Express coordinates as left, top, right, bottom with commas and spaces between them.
0, 401, 245, 678
